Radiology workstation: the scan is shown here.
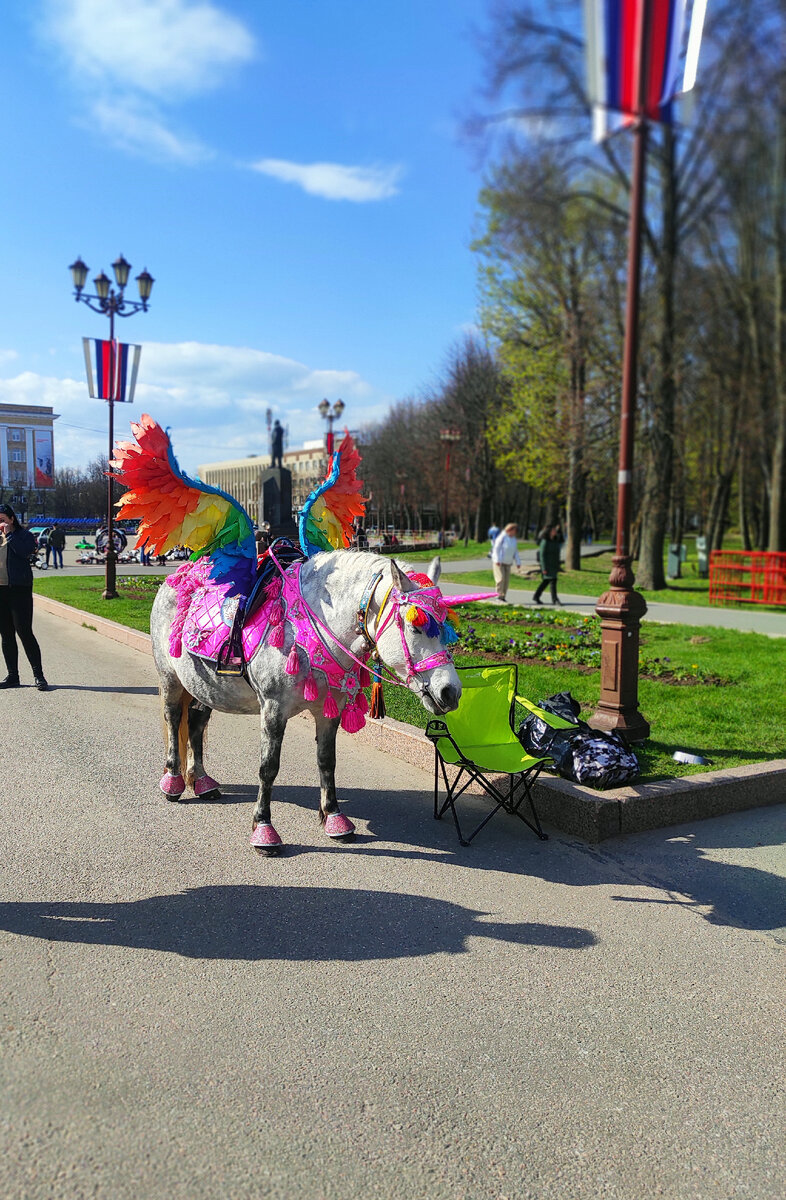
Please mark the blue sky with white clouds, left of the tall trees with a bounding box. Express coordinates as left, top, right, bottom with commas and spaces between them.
0, 0, 488, 470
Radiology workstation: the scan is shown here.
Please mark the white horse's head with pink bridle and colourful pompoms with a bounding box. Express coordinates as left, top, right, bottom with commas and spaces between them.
376, 558, 461, 716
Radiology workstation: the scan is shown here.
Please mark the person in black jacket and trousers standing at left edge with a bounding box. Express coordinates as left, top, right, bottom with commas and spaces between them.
0, 504, 49, 691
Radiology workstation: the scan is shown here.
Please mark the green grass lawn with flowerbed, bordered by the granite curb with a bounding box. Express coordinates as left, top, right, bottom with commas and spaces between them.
34, 575, 786, 780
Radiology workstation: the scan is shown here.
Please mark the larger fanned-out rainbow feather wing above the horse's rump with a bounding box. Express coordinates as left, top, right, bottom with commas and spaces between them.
110, 413, 257, 589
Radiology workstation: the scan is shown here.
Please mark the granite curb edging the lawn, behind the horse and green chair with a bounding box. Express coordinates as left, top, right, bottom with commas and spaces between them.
34, 593, 786, 842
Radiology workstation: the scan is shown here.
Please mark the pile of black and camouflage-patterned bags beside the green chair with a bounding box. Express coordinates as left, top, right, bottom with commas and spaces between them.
518, 691, 638, 788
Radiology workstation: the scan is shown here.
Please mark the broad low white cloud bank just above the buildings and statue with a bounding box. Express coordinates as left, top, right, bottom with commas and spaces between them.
0, 342, 390, 475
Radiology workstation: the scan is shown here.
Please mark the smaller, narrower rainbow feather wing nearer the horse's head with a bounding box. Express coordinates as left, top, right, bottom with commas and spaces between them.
299, 433, 366, 558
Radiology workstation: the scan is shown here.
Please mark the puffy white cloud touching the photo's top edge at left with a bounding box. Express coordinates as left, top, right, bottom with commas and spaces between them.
43, 0, 256, 98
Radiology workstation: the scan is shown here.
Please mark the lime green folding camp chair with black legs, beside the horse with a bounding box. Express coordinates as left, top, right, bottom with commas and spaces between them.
426, 664, 570, 846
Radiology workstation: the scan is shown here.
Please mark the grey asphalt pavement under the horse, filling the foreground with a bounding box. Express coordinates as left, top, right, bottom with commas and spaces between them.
0, 613, 786, 1200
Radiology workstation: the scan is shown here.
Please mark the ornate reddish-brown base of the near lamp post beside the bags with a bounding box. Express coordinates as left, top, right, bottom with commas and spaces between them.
589, 556, 649, 742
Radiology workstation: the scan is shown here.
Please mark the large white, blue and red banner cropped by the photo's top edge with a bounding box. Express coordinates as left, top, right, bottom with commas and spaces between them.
584, 0, 707, 142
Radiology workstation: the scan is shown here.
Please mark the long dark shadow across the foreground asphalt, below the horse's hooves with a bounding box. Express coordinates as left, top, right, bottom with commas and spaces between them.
0, 884, 596, 962
